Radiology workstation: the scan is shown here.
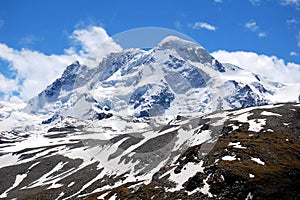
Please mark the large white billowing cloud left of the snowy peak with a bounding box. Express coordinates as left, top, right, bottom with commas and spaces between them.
0, 26, 121, 100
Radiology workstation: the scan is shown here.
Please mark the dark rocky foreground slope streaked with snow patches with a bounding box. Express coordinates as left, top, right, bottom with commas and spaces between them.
0, 103, 300, 199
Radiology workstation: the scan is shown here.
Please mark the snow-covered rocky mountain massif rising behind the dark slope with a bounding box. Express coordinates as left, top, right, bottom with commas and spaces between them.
25, 36, 299, 122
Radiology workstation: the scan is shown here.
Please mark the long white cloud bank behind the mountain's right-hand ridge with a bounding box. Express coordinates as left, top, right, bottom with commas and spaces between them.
212, 50, 300, 83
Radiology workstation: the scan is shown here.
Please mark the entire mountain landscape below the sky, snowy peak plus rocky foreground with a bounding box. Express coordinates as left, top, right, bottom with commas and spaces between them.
0, 36, 300, 199
